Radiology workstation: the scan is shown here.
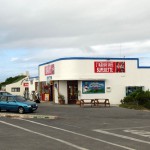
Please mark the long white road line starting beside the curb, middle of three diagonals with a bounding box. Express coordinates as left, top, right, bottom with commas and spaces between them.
20, 119, 135, 150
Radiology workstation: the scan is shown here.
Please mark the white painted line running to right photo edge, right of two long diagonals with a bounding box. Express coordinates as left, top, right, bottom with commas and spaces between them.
93, 129, 150, 144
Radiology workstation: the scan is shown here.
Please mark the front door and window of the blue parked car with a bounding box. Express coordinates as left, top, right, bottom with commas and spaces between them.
6, 96, 18, 111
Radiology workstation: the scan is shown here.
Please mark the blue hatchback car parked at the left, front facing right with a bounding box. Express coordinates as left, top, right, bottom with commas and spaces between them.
0, 95, 38, 114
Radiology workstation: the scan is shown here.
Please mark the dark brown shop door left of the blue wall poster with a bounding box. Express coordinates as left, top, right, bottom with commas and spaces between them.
67, 81, 78, 104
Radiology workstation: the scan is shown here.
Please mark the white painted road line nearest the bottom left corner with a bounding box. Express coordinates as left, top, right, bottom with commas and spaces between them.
0, 121, 88, 150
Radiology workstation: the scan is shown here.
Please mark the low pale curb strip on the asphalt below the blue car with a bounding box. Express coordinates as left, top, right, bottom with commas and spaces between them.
0, 113, 58, 119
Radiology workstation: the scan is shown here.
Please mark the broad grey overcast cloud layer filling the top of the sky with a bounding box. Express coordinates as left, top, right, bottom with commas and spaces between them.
0, 0, 150, 48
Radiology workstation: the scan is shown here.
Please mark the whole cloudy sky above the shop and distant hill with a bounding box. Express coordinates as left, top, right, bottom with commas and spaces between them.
0, 0, 150, 82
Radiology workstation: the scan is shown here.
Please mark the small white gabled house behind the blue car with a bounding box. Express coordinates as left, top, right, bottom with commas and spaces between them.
6, 76, 29, 98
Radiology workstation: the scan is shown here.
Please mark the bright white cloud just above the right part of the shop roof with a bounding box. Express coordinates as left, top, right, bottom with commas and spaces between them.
93, 40, 150, 57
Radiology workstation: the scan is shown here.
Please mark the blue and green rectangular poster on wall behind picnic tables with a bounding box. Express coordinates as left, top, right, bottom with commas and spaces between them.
82, 81, 105, 94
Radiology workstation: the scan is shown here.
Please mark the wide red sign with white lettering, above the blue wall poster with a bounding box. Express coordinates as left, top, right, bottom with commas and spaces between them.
94, 61, 125, 73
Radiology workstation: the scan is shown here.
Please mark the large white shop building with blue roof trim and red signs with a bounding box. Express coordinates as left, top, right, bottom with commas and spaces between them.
39, 57, 150, 104
